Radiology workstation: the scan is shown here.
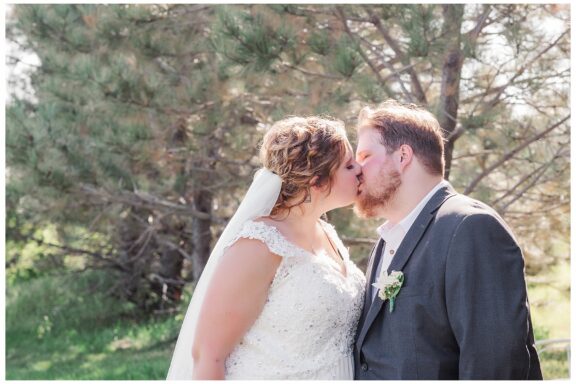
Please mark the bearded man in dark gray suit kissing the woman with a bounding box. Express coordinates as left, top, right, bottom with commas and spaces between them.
354, 101, 542, 380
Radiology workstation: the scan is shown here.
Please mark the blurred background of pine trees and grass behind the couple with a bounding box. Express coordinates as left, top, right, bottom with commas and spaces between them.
5, 4, 570, 379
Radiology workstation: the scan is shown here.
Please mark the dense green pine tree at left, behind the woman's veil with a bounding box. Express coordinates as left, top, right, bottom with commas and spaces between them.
7, 5, 274, 309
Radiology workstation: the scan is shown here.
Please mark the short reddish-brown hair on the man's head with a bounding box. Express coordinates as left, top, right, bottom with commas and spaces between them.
357, 100, 444, 176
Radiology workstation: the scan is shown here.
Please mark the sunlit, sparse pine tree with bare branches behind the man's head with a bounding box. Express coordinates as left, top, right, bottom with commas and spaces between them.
209, 4, 570, 271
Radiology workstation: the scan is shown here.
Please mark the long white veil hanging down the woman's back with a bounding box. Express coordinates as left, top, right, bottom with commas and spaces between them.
166, 168, 282, 380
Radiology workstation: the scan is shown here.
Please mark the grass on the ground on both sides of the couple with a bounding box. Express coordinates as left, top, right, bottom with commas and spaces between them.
6, 266, 570, 380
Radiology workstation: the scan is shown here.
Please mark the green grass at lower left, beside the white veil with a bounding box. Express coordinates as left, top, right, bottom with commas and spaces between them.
6, 274, 180, 380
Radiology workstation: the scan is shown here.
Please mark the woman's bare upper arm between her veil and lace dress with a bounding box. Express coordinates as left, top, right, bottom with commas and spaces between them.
192, 239, 281, 380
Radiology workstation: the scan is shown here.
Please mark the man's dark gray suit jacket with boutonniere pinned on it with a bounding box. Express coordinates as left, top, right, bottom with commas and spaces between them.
354, 187, 542, 380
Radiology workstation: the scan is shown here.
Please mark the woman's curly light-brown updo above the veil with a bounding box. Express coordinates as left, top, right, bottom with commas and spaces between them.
260, 116, 352, 216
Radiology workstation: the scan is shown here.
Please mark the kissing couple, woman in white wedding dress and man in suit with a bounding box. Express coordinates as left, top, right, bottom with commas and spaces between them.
168, 100, 542, 380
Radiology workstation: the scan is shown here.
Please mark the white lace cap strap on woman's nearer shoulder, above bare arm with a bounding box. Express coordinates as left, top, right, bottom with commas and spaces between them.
227, 220, 307, 257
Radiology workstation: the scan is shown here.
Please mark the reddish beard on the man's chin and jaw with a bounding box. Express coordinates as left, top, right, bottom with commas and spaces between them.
354, 171, 402, 218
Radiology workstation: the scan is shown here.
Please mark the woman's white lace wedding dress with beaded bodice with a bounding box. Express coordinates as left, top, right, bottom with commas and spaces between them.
225, 220, 365, 380
